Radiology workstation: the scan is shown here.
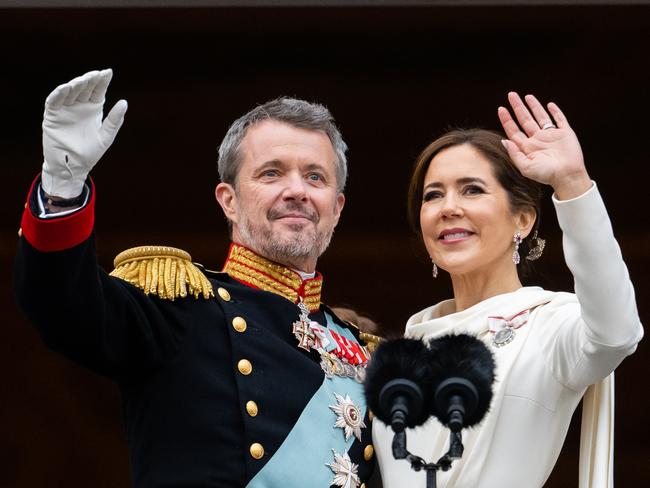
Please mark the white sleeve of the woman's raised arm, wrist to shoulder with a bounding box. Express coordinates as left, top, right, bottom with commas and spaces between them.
545, 184, 643, 391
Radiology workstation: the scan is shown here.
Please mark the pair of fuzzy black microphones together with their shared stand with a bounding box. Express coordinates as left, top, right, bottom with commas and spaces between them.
364, 334, 495, 476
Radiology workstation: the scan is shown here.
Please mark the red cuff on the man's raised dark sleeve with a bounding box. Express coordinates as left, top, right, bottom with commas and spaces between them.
21, 175, 95, 252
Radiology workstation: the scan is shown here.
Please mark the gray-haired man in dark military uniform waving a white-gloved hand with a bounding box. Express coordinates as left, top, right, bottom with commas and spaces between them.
14, 70, 374, 488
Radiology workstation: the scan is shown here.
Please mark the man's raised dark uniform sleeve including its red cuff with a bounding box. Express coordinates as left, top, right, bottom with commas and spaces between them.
13, 177, 186, 382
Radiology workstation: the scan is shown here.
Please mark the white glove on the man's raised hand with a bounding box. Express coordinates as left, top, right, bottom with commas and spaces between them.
41, 69, 127, 199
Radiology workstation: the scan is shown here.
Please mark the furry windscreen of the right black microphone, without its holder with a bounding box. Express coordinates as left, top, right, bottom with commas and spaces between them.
425, 334, 495, 427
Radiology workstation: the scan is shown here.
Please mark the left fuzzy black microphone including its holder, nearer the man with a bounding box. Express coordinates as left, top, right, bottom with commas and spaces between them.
364, 339, 434, 433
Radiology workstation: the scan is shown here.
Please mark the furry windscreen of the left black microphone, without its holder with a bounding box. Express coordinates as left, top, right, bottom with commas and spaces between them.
364, 339, 433, 427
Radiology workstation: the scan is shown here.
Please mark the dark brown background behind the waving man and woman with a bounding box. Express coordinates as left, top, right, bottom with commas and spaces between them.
0, 7, 650, 487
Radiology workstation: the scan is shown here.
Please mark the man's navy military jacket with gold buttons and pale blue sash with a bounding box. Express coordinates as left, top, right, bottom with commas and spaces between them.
14, 177, 374, 488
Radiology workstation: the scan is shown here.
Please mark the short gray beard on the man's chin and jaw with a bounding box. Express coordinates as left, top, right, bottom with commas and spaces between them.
239, 216, 334, 264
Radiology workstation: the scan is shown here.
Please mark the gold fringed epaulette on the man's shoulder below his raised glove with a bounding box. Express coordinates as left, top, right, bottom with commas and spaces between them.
111, 246, 214, 300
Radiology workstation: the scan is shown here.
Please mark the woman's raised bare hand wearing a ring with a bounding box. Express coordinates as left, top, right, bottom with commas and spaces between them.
498, 92, 591, 200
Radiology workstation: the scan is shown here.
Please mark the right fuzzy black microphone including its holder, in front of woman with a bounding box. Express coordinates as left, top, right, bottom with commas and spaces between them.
426, 334, 495, 433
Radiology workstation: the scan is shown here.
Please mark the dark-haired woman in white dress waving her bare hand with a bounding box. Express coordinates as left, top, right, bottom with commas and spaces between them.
374, 93, 643, 488
